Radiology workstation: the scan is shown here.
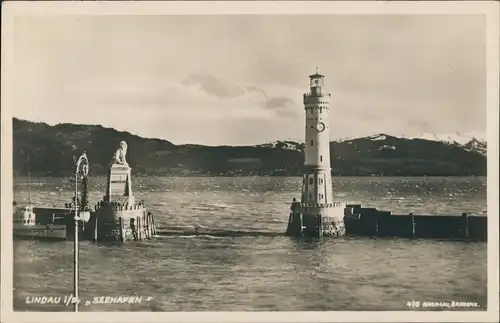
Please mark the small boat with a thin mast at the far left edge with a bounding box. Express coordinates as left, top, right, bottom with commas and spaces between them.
13, 157, 67, 240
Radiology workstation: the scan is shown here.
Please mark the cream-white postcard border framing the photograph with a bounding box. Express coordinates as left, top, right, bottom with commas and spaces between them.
0, 1, 499, 323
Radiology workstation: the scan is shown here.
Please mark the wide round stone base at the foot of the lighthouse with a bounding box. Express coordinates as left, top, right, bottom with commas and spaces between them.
286, 202, 346, 238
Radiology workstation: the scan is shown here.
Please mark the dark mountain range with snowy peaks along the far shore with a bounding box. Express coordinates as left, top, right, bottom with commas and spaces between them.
13, 118, 486, 176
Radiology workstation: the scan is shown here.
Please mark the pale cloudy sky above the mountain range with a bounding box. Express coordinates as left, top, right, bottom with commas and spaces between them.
12, 15, 486, 145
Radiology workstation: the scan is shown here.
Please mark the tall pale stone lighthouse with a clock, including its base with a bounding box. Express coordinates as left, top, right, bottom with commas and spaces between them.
287, 68, 346, 237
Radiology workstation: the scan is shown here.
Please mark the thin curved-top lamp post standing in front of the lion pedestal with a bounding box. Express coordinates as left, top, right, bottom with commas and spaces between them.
73, 153, 90, 312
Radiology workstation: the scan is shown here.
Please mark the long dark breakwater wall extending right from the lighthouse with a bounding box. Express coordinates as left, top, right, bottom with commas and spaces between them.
344, 205, 488, 241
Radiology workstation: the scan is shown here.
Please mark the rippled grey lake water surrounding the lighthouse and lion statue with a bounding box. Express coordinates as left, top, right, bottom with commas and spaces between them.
14, 177, 487, 311
